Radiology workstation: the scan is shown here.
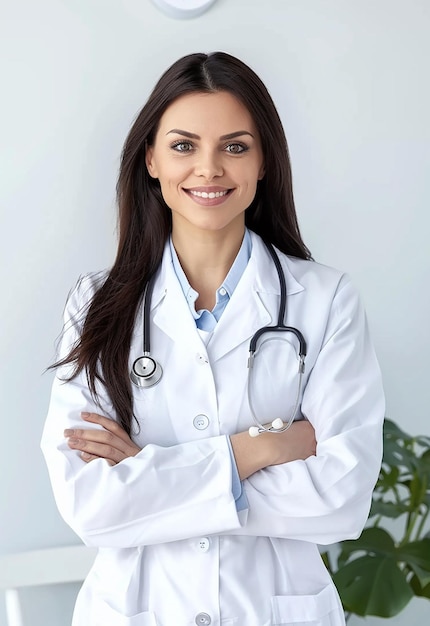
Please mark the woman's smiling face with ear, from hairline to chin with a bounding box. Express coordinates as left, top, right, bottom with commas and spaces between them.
146, 92, 264, 234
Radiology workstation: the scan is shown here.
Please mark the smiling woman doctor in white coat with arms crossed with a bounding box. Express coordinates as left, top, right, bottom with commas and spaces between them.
42, 53, 384, 626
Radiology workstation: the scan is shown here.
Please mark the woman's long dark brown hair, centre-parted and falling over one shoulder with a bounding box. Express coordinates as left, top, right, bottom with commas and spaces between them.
52, 52, 311, 434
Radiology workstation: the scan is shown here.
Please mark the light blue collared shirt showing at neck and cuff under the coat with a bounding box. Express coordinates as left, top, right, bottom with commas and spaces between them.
170, 228, 252, 511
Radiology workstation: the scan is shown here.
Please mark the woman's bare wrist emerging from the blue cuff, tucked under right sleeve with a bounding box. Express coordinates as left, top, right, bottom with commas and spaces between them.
230, 420, 316, 480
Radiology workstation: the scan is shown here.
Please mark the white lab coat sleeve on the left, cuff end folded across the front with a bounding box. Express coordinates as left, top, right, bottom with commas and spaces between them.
42, 279, 245, 547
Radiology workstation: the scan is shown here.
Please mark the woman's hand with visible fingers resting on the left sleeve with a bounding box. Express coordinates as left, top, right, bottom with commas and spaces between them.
64, 413, 141, 465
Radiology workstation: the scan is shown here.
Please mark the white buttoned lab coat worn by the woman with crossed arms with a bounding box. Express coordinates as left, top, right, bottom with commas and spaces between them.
42, 233, 384, 626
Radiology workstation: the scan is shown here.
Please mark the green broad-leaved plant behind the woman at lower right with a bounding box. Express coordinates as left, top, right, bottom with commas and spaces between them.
323, 419, 430, 617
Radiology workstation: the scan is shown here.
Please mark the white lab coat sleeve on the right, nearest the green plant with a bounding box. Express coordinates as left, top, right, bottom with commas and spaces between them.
232, 277, 385, 544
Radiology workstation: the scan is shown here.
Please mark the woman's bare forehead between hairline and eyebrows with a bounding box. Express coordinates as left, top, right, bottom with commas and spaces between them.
159, 91, 256, 134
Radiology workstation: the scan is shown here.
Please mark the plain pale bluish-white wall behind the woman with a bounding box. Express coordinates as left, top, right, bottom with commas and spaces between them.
0, 0, 430, 626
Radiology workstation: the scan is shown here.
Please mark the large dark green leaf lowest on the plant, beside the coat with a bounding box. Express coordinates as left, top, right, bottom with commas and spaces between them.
333, 554, 413, 617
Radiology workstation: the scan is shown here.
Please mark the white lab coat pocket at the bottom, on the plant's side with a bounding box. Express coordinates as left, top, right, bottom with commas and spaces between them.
272, 585, 345, 626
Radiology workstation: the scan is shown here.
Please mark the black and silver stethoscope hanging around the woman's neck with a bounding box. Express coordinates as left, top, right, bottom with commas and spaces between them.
130, 242, 307, 437
